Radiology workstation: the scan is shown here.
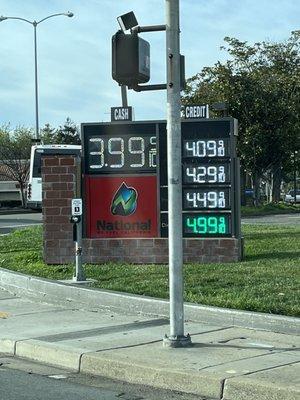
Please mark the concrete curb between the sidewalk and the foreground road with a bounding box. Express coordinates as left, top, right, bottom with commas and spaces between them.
0, 339, 299, 400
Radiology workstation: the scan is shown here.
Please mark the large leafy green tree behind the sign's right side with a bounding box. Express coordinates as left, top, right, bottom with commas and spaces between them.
183, 31, 300, 202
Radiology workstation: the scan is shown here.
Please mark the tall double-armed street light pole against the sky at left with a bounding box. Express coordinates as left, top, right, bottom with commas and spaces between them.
0, 11, 74, 142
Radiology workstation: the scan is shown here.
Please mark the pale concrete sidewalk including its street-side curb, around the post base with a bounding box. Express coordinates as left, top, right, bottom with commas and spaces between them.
0, 274, 300, 400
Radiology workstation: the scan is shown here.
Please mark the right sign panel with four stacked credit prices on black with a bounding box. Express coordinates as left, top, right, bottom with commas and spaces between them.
159, 118, 239, 238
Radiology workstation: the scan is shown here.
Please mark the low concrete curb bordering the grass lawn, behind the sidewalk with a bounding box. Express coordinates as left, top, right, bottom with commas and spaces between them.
0, 268, 300, 335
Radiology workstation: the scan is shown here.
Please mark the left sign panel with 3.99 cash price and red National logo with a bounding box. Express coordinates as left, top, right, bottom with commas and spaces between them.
81, 122, 159, 238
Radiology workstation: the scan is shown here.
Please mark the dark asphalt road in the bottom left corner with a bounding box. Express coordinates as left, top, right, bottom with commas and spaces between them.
0, 354, 201, 400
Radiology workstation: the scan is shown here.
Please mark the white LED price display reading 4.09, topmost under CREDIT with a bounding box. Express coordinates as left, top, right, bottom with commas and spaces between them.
182, 139, 229, 158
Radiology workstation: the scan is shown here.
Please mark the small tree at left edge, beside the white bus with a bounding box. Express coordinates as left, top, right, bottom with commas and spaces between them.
0, 126, 33, 207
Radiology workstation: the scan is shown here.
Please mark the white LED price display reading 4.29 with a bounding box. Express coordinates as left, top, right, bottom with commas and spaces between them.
183, 163, 230, 184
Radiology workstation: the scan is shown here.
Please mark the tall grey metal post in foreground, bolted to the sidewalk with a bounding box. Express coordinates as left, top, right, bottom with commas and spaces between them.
163, 0, 191, 347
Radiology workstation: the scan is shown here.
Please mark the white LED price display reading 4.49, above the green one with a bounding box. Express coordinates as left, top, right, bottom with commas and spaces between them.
183, 188, 230, 210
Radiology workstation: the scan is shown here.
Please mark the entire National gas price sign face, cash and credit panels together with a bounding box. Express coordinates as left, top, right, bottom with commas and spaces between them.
82, 118, 240, 238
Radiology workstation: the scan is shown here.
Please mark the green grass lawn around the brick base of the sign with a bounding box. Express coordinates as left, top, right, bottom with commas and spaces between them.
0, 225, 300, 317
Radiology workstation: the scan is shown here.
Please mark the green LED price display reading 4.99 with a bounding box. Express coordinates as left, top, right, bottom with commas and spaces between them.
183, 213, 231, 237
